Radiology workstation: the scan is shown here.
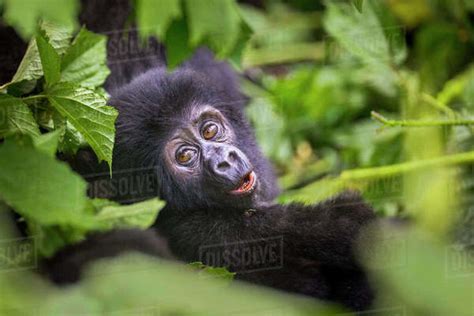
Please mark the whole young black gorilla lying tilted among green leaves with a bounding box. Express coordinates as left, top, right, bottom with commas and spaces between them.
47, 52, 374, 310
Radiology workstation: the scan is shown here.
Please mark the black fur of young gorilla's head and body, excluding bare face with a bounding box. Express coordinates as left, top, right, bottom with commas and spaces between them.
63, 51, 375, 310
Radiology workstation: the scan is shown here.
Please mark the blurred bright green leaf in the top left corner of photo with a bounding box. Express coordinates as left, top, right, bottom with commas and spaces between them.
4, 0, 79, 39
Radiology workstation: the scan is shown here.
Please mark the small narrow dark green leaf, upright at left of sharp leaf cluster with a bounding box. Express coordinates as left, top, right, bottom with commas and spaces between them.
36, 34, 61, 85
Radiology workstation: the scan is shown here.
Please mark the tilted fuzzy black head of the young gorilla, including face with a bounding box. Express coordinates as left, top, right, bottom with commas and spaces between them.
109, 67, 278, 210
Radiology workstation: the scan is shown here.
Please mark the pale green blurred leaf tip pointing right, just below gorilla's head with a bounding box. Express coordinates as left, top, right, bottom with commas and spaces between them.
96, 199, 165, 229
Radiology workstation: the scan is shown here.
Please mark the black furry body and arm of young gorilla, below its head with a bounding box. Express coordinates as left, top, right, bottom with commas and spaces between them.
156, 192, 375, 310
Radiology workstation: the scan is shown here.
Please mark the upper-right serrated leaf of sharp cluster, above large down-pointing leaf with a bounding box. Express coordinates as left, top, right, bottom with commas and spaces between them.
61, 29, 110, 88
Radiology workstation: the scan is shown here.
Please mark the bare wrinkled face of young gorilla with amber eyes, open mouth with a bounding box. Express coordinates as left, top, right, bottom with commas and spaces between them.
163, 105, 259, 210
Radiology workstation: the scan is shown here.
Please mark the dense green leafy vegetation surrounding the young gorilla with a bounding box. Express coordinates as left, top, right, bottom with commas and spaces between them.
0, 0, 474, 315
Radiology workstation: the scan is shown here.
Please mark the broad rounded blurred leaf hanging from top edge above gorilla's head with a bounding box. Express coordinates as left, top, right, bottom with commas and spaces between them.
185, 0, 241, 56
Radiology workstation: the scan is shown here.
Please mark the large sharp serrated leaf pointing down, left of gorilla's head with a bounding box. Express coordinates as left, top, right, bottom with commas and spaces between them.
46, 83, 118, 166
